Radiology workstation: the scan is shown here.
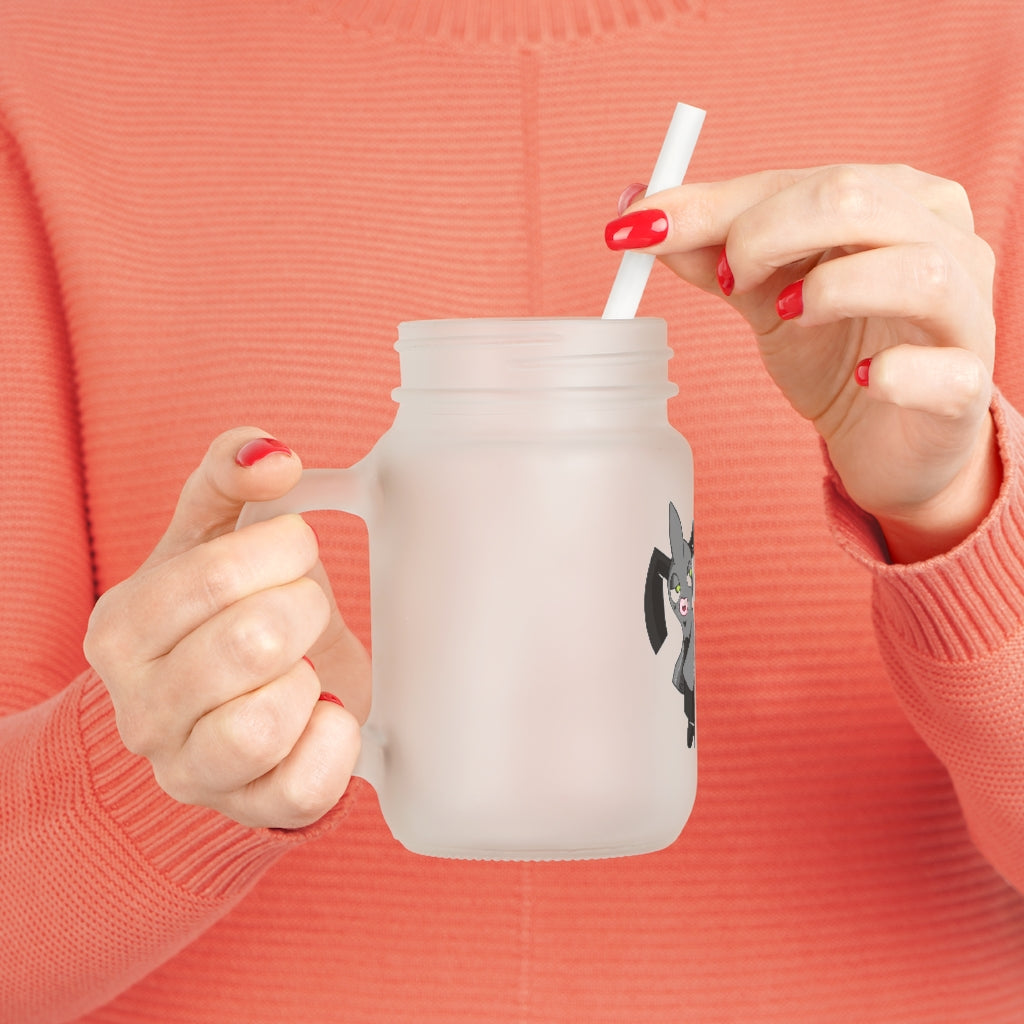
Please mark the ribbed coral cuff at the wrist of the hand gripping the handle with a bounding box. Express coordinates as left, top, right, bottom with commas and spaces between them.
79, 672, 351, 902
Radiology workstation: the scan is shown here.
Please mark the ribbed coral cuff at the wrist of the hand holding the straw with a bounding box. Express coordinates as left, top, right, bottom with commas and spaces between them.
825, 392, 1024, 660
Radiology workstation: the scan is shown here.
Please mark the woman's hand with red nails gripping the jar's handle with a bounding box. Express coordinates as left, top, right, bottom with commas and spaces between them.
85, 428, 370, 828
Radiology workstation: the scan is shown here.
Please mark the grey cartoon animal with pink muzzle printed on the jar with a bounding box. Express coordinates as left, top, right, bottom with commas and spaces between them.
644, 502, 696, 746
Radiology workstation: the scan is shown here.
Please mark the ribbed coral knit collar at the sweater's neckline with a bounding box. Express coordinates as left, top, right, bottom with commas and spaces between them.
314, 0, 708, 45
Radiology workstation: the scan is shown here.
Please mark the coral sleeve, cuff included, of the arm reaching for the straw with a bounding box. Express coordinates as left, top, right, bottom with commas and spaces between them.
825, 393, 1024, 892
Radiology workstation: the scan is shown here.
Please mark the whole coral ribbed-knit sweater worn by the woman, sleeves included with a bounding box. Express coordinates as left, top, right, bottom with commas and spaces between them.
0, 0, 1024, 1024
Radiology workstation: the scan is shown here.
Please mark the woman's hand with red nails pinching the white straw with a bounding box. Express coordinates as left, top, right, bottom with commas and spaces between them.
606, 166, 1001, 562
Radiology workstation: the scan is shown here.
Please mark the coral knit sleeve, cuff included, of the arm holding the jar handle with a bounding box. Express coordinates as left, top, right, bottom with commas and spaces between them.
0, 133, 345, 1024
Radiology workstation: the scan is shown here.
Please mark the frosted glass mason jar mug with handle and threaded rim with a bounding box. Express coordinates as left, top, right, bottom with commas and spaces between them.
240, 318, 696, 860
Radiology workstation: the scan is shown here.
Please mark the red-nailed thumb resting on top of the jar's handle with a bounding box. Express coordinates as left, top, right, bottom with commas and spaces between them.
145, 427, 302, 565
